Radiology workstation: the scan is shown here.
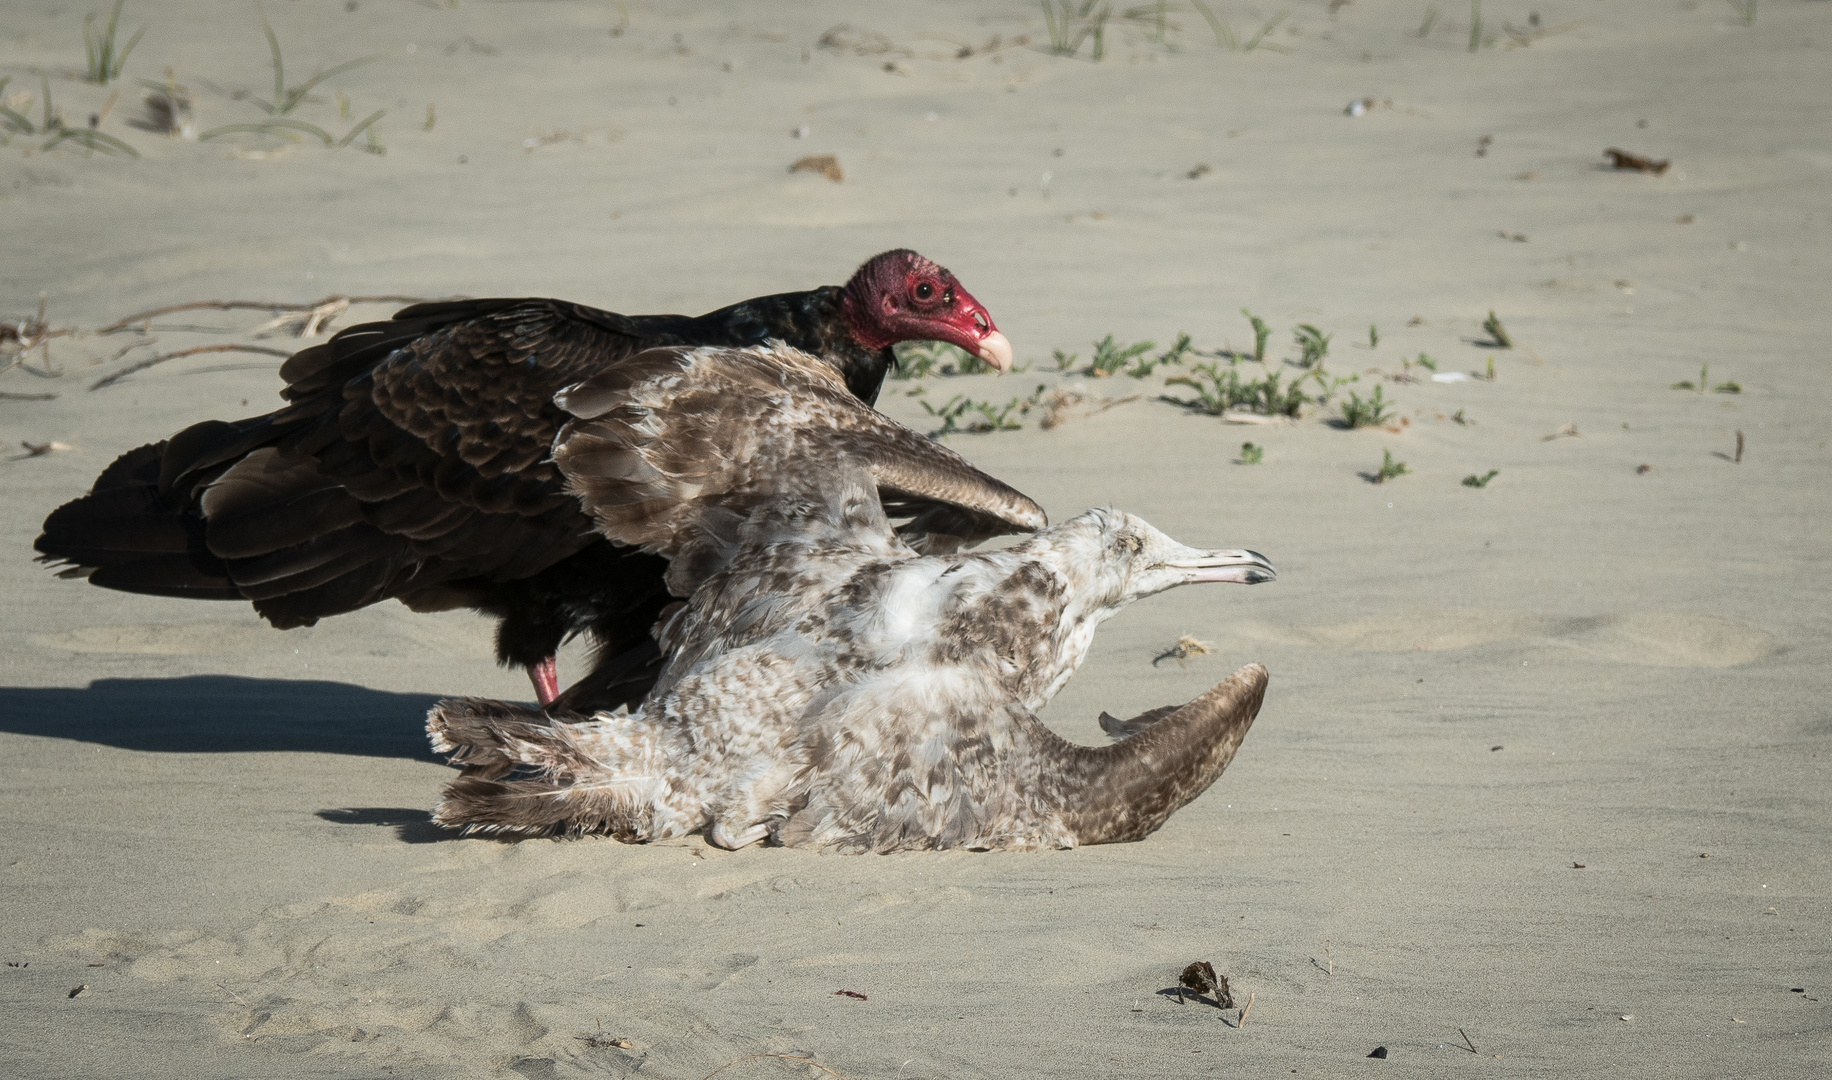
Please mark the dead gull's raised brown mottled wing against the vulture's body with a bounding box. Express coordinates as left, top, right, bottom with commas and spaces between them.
553, 344, 1046, 595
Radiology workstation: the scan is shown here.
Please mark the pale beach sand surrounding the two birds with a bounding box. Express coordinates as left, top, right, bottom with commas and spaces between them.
0, 0, 1832, 1080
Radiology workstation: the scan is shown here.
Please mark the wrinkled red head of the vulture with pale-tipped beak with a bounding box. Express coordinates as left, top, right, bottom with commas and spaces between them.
843, 249, 1011, 372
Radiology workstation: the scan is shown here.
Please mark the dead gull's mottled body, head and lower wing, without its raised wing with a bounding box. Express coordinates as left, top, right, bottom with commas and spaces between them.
427, 470, 1273, 851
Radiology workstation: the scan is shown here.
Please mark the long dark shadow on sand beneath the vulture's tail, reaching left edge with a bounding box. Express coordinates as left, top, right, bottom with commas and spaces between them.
0, 675, 440, 761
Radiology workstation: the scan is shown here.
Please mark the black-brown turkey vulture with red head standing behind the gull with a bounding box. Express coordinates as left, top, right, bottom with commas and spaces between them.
35, 251, 1018, 705
